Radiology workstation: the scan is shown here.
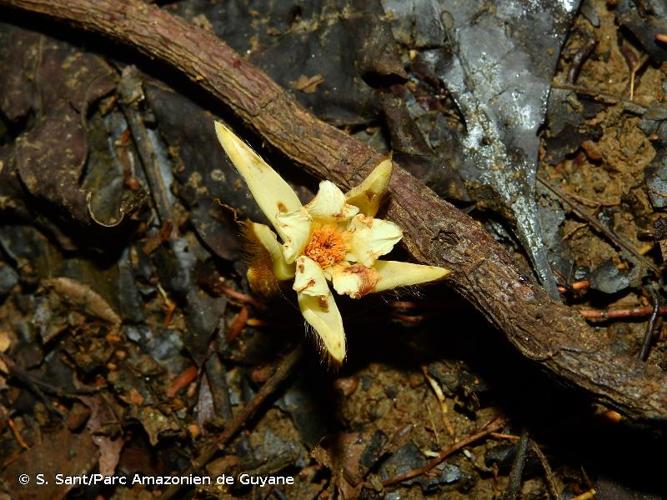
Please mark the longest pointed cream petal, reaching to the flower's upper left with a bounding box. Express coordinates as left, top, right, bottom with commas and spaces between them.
215, 122, 301, 230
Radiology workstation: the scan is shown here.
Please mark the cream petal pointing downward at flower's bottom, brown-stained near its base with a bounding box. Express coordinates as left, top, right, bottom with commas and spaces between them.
298, 293, 345, 364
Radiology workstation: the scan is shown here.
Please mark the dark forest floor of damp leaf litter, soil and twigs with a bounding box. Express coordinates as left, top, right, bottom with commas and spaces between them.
0, 0, 667, 500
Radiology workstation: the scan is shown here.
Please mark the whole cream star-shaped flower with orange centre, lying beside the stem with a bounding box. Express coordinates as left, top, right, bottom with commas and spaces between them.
215, 122, 449, 363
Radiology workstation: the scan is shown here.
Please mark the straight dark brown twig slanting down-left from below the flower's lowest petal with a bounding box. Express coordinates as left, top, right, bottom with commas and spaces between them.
160, 345, 303, 499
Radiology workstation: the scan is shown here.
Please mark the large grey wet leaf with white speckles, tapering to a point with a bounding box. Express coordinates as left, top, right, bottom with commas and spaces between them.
386, 0, 578, 297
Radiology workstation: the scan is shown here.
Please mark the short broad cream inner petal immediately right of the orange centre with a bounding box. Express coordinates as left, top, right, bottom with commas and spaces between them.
347, 214, 403, 267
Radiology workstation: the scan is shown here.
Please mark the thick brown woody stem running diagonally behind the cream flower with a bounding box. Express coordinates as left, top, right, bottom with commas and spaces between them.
0, 0, 667, 420
